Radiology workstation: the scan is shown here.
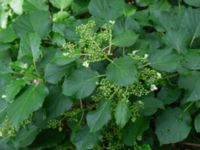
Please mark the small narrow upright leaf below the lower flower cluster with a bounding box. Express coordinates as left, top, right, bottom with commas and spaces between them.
115, 100, 130, 128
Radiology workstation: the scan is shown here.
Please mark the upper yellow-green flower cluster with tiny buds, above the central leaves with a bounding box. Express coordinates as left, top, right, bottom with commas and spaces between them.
63, 20, 112, 64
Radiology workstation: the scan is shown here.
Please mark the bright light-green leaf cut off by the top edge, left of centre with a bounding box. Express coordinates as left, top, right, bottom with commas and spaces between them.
50, 0, 73, 10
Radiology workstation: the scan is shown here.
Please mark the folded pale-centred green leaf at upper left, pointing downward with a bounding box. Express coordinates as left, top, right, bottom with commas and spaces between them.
18, 33, 42, 62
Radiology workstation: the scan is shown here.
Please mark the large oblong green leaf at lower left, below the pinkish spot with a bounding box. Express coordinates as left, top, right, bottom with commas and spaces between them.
7, 84, 48, 126
